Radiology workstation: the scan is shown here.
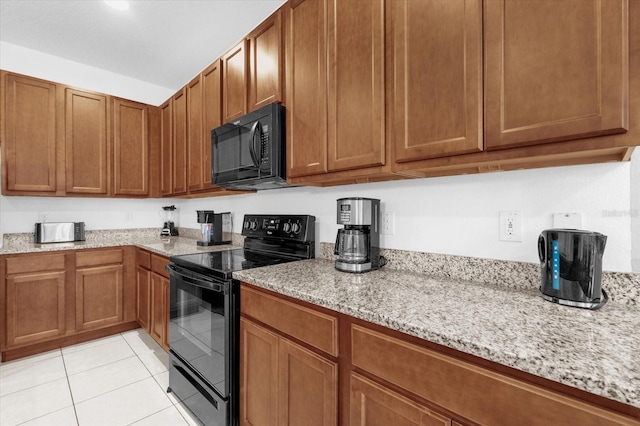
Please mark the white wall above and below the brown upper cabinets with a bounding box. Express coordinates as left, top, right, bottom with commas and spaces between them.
0, 43, 640, 271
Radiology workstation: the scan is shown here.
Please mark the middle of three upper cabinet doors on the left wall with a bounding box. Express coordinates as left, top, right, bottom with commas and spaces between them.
65, 89, 110, 195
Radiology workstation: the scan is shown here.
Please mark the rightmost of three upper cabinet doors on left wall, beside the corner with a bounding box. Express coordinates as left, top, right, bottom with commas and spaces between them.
113, 98, 149, 195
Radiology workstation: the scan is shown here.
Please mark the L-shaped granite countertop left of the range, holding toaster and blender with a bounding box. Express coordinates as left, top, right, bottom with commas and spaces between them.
0, 228, 242, 257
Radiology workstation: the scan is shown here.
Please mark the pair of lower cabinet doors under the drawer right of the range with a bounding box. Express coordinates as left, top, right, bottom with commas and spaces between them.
240, 318, 338, 426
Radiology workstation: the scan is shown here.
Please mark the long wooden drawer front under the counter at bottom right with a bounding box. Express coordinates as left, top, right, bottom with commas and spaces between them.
351, 325, 633, 426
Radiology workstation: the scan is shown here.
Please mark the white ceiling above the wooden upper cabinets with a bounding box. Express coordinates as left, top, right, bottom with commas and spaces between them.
0, 0, 285, 91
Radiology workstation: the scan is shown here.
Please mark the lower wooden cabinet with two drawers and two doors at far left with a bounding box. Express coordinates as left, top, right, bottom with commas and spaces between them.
0, 247, 137, 361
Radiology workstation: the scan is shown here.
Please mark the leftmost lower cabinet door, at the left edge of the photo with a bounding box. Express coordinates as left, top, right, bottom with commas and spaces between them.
6, 271, 66, 348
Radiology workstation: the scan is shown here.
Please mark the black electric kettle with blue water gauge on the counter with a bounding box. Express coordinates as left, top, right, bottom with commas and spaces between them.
538, 229, 608, 309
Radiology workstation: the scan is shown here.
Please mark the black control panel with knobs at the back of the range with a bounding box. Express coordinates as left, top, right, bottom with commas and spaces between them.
242, 214, 316, 242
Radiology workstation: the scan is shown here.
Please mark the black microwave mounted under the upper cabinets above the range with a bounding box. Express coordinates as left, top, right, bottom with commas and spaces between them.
211, 103, 287, 190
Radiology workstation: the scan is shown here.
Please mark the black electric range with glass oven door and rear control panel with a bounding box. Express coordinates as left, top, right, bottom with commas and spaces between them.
167, 215, 315, 426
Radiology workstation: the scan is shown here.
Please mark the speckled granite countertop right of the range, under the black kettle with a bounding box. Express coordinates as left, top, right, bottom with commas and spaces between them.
233, 259, 640, 408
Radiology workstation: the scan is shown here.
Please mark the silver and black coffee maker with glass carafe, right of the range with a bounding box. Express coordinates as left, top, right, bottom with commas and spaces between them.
334, 197, 380, 273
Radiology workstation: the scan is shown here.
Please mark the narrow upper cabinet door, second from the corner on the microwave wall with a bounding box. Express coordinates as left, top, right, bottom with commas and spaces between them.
172, 87, 187, 195
